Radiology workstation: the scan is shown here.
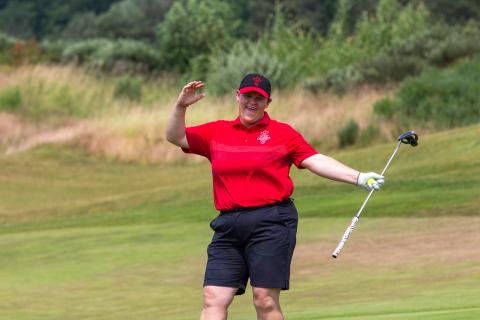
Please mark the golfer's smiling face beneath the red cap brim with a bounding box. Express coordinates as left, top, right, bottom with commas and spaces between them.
237, 91, 271, 127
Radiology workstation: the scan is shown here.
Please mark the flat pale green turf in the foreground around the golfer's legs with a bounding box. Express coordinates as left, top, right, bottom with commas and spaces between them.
0, 217, 480, 319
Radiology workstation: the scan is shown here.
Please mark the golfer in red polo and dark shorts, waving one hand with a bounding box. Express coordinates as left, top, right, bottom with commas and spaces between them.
167, 74, 384, 320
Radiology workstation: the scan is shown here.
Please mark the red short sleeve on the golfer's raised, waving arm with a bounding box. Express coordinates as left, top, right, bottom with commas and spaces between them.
182, 122, 215, 159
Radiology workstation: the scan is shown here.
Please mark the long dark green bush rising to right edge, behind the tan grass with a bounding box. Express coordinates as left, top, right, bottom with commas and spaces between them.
316, 23, 480, 94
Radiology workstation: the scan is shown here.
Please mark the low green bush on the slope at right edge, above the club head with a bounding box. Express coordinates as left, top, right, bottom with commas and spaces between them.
374, 56, 480, 128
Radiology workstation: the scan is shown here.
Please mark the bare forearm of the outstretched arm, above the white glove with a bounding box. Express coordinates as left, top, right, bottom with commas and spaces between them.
301, 154, 360, 185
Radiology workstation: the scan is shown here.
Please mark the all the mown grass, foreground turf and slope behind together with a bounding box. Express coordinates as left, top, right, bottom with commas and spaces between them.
0, 126, 480, 320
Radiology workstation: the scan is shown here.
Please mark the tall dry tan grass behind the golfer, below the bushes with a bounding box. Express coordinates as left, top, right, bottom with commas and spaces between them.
0, 65, 398, 162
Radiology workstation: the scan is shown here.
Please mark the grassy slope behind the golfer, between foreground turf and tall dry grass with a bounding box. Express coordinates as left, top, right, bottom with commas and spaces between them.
0, 126, 480, 232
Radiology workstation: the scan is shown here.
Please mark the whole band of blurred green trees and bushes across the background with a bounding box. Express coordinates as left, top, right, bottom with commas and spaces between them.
0, 0, 480, 146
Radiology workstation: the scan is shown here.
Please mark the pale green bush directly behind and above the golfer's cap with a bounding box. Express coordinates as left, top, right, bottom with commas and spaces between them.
207, 7, 316, 94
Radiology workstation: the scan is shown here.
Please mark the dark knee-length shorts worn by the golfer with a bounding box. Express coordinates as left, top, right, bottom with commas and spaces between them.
203, 200, 298, 295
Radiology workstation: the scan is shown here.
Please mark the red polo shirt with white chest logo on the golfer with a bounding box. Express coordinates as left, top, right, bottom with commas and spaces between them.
183, 113, 317, 210
